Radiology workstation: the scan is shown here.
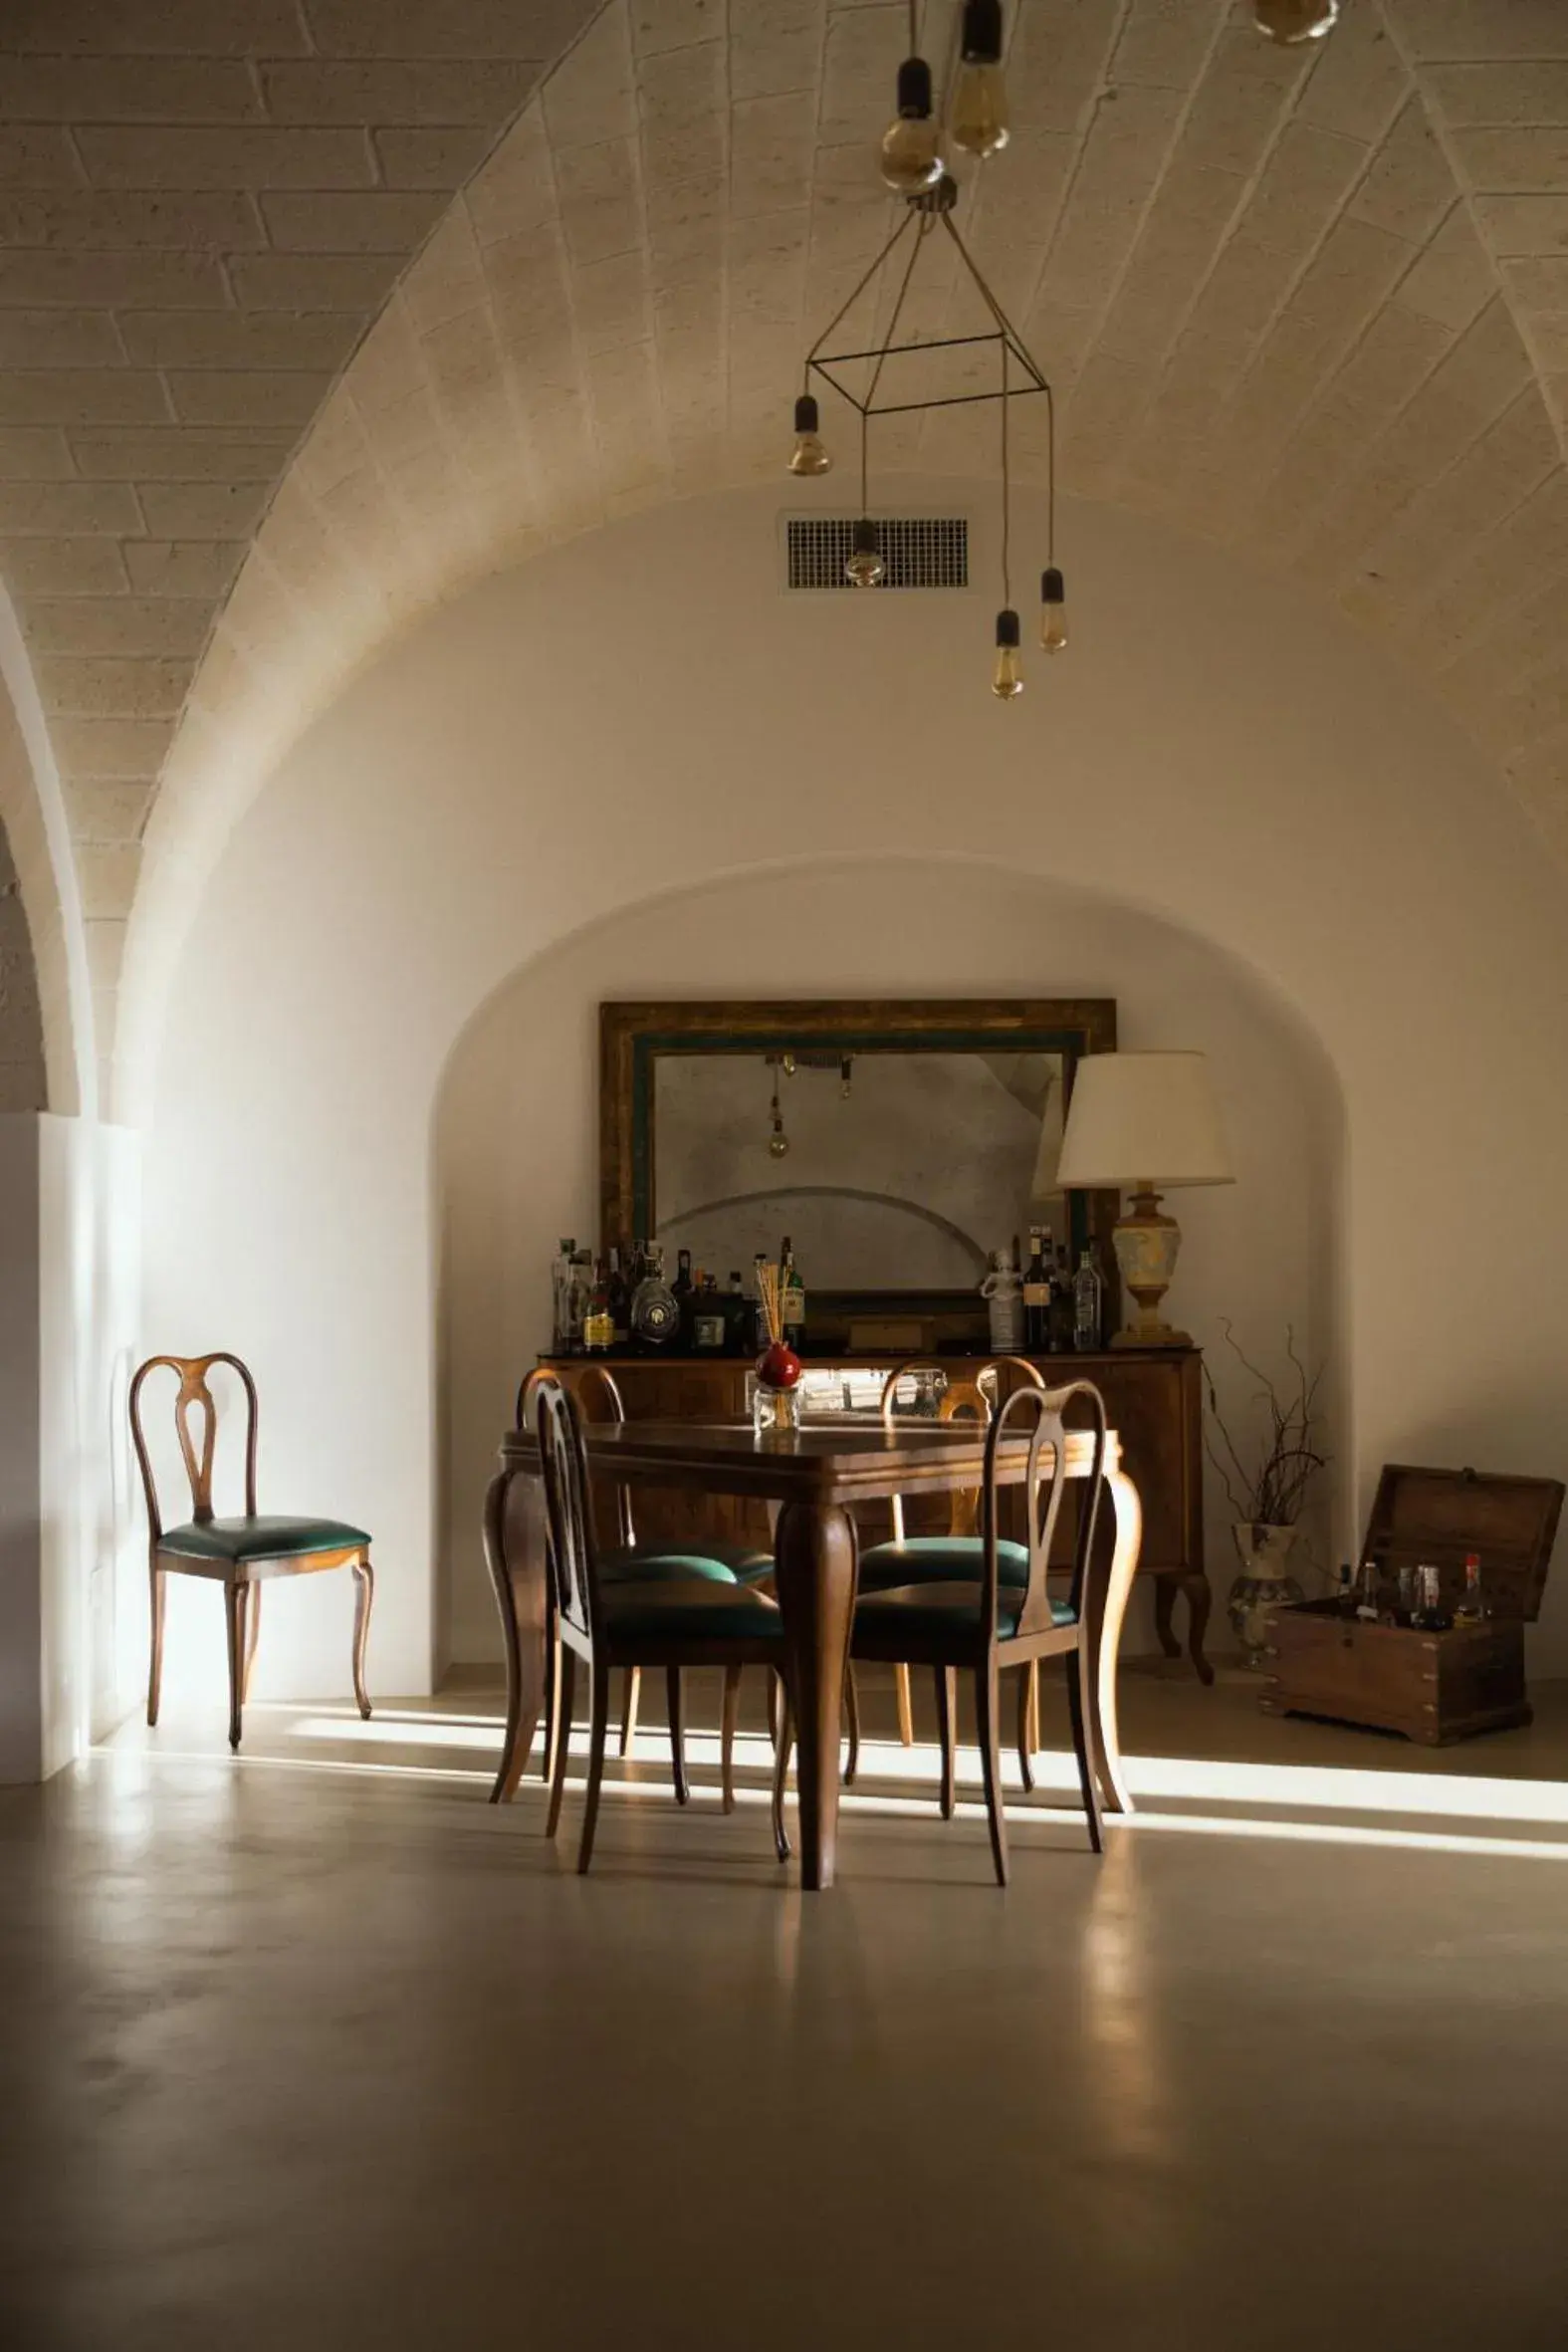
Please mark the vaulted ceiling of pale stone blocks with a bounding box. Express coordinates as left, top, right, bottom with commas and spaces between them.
0, 0, 1568, 1100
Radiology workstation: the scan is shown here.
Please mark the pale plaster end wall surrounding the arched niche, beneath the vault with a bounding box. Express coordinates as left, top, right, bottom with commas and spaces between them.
145, 482, 1568, 1721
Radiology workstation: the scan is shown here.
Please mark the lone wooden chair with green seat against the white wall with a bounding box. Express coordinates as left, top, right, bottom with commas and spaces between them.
129, 1350, 376, 1750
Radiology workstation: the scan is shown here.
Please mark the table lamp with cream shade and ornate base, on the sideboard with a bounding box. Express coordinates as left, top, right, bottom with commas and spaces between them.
1055, 1054, 1234, 1347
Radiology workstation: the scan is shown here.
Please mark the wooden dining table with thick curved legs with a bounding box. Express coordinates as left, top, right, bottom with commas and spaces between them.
484, 1421, 1143, 1889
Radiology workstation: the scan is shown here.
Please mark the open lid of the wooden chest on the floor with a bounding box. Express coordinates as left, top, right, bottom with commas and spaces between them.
1361, 1463, 1563, 1618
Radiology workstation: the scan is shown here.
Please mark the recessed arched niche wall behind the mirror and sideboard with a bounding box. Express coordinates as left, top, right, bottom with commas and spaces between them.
435, 856, 1345, 1665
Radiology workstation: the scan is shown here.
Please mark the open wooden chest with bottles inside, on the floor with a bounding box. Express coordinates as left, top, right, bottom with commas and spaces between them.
1262, 1463, 1563, 1748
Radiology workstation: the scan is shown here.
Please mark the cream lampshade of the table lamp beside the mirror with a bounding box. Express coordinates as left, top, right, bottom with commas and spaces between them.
1055, 1054, 1234, 1193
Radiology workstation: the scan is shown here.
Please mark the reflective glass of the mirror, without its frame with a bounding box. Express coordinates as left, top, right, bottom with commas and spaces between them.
653, 1049, 1062, 1289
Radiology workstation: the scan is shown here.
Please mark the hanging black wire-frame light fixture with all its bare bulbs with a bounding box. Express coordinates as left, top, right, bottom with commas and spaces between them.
789, 0, 1340, 701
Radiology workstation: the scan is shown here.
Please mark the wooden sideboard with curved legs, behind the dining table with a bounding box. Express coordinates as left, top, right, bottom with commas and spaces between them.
543, 1347, 1213, 1682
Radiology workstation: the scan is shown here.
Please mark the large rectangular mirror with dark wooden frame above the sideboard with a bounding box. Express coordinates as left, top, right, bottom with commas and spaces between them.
599, 997, 1117, 1336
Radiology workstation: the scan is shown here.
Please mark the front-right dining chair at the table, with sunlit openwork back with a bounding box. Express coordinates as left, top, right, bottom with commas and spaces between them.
851, 1380, 1107, 1886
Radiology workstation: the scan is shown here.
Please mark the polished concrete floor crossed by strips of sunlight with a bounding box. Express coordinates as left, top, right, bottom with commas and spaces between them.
0, 1675, 1568, 2352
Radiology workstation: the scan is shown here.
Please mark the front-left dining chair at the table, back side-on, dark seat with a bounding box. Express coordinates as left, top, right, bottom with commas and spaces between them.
532, 1373, 789, 1870
